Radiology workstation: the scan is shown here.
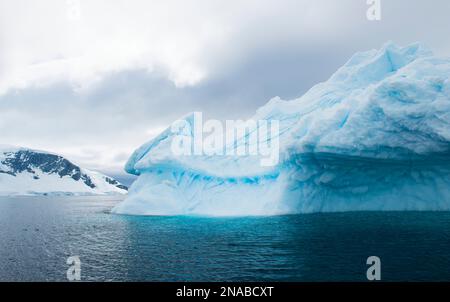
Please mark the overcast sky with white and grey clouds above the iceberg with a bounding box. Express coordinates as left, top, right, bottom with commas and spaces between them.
0, 0, 450, 174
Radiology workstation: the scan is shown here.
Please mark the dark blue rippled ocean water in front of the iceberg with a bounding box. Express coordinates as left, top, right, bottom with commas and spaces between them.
0, 197, 450, 281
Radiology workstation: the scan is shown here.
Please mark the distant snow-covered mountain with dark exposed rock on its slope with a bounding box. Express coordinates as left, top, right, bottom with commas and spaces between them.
0, 146, 127, 196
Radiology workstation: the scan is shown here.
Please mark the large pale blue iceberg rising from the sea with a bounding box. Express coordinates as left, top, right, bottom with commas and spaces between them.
113, 43, 450, 216
